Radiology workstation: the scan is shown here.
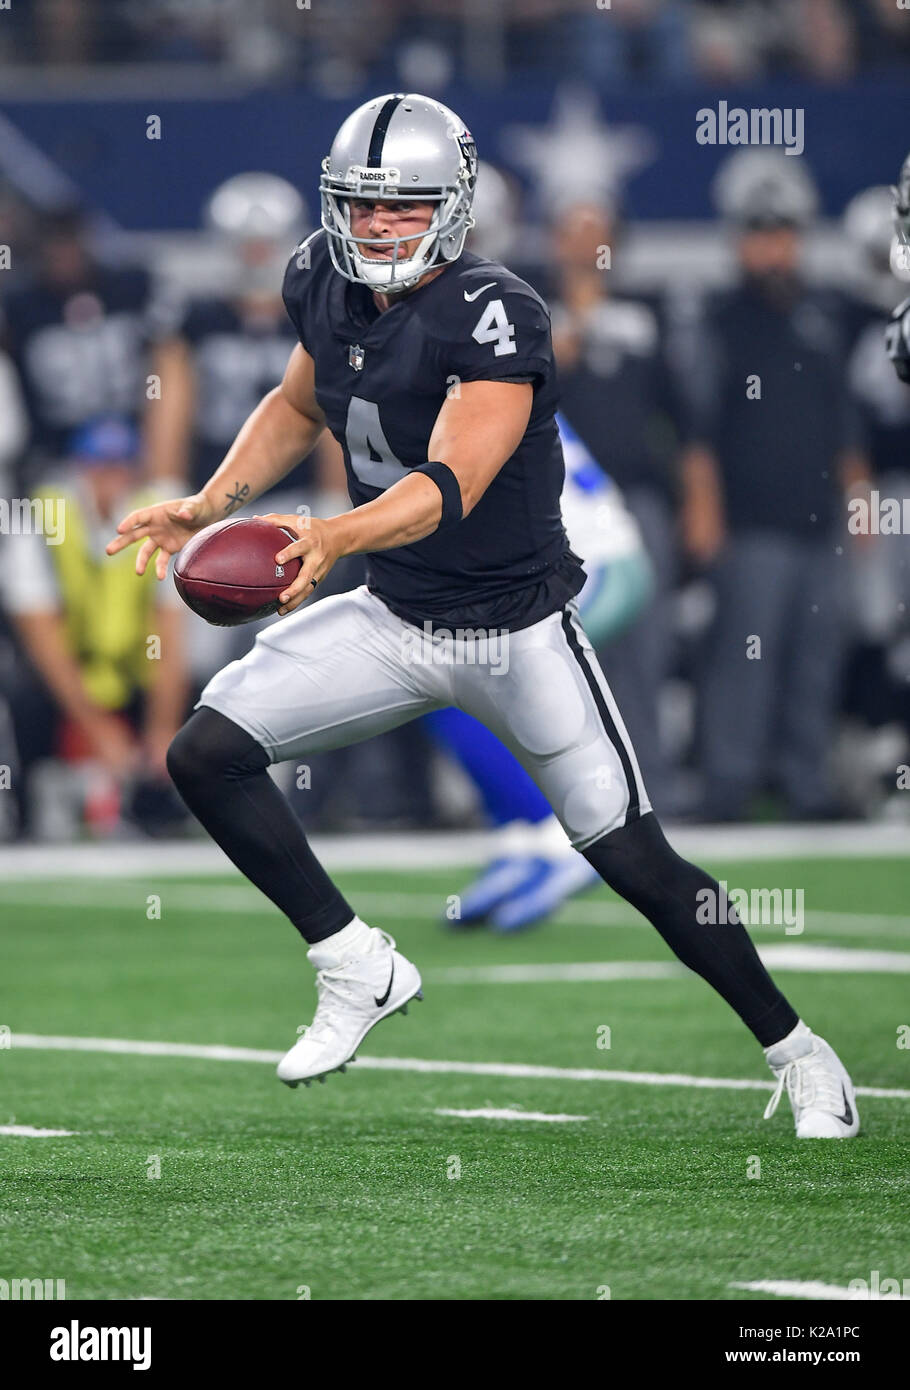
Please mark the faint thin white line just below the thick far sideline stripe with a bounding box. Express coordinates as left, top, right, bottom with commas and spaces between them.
0, 873, 910, 940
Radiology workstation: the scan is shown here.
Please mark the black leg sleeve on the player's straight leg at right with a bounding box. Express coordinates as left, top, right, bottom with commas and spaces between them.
582, 812, 799, 1047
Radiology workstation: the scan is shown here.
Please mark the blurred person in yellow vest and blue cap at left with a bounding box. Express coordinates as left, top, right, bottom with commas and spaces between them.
0, 417, 188, 838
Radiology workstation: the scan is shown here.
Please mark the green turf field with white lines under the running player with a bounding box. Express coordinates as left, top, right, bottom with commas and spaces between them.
0, 859, 910, 1300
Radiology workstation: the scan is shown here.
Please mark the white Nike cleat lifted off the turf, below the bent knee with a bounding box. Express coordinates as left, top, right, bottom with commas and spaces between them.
278, 927, 424, 1086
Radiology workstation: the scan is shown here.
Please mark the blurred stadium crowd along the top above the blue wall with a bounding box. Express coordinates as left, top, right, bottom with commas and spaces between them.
0, 0, 910, 90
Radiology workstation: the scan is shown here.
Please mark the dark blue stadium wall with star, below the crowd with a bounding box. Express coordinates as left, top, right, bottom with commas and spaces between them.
1, 76, 910, 229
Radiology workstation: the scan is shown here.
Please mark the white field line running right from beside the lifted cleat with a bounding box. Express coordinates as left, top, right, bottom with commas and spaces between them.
425, 945, 910, 984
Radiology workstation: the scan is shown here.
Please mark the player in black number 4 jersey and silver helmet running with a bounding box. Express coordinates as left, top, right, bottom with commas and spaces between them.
108, 93, 859, 1138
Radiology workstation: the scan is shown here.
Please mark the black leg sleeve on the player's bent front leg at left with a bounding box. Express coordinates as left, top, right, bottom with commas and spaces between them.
168, 705, 354, 941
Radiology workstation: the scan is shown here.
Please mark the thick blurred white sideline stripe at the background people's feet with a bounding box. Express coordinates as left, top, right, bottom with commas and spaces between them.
0, 821, 910, 878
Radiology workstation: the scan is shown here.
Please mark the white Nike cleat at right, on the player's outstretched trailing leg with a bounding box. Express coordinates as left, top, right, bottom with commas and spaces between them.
764, 1019, 860, 1138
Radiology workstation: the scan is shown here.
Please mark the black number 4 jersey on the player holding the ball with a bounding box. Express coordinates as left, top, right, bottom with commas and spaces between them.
285, 232, 585, 630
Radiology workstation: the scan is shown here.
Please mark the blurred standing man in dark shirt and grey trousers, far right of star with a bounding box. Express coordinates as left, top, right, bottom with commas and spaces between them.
682, 150, 866, 821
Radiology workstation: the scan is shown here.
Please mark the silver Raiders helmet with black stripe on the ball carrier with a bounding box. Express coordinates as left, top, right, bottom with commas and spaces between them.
320, 93, 477, 295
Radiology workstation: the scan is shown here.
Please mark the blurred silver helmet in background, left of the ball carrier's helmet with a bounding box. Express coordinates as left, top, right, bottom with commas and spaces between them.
206, 171, 310, 295
